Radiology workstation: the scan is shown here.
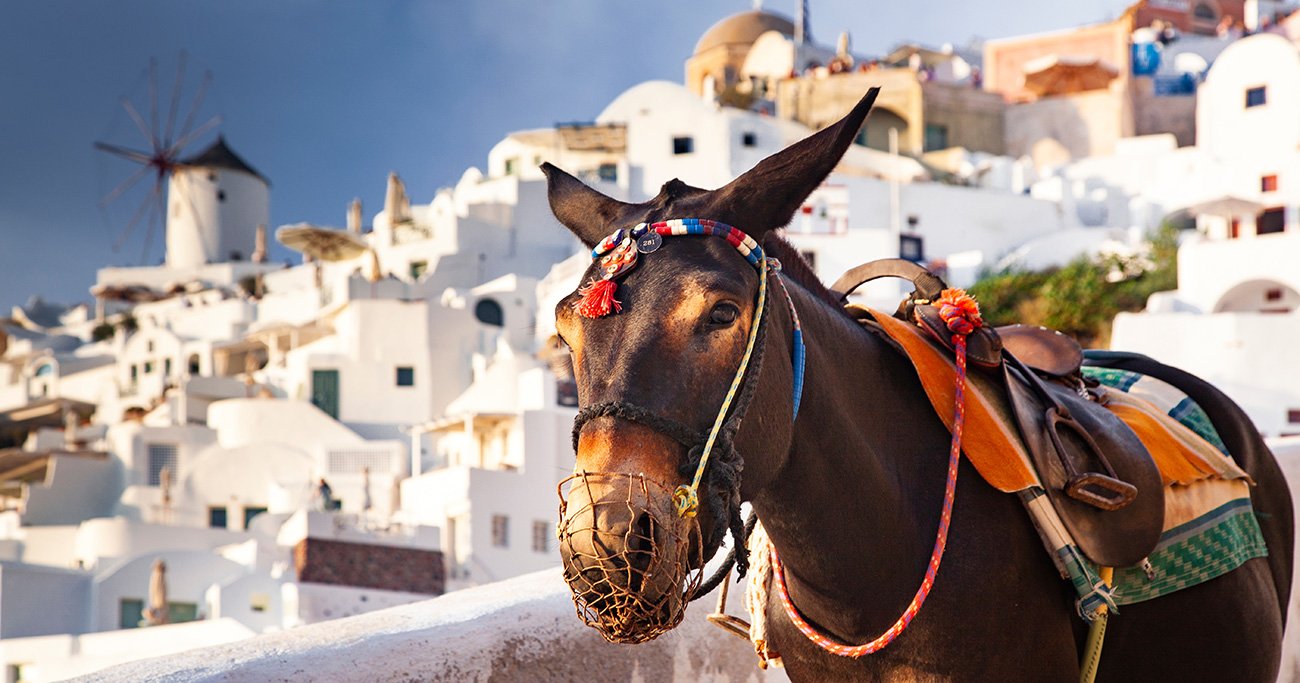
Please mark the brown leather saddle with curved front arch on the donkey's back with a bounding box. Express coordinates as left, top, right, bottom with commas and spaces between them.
831, 259, 1165, 567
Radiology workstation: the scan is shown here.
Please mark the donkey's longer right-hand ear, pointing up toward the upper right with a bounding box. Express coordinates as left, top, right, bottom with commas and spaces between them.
709, 87, 880, 238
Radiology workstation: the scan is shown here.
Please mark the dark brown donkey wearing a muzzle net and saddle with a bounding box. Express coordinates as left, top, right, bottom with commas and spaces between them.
542, 92, 1292, 682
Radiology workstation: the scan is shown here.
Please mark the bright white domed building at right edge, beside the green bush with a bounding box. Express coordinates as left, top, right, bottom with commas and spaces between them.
1074, 34, 1300, 436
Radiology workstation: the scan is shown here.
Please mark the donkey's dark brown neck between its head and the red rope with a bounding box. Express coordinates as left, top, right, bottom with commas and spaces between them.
749, 285, 948, 639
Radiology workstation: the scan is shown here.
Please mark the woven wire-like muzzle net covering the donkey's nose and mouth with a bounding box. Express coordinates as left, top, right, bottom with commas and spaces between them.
556, 472, 703, 643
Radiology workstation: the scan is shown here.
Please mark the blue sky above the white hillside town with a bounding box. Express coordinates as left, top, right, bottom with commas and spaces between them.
0, 0, 1126, 310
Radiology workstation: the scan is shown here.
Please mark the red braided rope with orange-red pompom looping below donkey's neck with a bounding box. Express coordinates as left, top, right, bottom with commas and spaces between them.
768, 289, 984, 658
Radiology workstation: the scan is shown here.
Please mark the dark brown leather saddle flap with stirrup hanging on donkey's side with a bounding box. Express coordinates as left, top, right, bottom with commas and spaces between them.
1005, 367, 1165, 567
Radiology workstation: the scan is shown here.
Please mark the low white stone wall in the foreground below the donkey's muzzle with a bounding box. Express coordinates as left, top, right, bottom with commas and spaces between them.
81, 570, 787, 683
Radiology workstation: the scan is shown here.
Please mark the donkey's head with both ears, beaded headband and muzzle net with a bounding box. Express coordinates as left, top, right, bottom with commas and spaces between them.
542, 88, 876, 641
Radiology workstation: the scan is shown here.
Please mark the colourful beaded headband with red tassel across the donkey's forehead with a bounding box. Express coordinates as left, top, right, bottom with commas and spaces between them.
573, 219, 763, 317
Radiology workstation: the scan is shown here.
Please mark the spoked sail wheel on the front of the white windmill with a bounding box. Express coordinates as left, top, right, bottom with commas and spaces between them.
95, 52, 221, 263
